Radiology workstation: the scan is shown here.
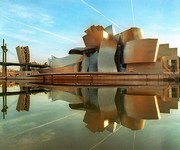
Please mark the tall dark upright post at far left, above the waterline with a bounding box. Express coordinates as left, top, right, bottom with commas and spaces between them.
1, 39, 8, 78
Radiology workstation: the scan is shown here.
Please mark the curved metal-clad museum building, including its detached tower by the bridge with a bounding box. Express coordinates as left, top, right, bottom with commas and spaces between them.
17, 25, 179, 77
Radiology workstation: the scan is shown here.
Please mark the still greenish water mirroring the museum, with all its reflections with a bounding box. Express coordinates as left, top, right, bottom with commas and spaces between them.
0, 82, 180, 150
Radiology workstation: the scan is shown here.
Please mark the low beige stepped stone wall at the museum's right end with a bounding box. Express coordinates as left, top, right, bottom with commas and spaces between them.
127, 44, 179, 74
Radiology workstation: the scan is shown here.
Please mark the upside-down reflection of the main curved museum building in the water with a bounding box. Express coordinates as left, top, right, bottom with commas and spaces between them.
50, 85, 179, 132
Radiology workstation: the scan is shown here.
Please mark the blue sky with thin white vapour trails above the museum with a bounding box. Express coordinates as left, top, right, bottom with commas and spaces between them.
0, 0, 180, 63
